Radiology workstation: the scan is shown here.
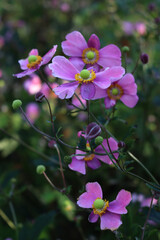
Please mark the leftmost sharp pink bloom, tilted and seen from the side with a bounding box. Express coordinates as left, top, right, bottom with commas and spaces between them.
13, 45, 57, 78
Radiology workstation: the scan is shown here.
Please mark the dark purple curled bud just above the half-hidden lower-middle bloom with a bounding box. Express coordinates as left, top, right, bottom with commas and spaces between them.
85, 122, 101, 140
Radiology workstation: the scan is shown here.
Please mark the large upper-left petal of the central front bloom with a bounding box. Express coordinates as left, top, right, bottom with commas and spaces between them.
49, 56, 79, 80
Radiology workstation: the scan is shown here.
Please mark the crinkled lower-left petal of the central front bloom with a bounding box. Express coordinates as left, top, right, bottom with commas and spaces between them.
53, 82, 78, 99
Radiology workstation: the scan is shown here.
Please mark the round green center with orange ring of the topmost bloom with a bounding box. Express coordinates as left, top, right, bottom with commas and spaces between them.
82, 48, 99, 65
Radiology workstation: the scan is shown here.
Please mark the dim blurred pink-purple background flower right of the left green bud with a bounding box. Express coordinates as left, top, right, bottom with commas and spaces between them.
26, 103, 40, 123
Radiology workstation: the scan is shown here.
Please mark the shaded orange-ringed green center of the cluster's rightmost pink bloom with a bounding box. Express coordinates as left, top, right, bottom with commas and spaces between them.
107, 83, 123, 100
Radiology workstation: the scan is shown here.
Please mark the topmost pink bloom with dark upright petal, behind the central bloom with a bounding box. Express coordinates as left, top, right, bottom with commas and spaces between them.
62, 31, 121, 68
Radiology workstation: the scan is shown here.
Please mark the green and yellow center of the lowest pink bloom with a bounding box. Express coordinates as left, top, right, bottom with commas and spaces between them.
92, 198, 109, 217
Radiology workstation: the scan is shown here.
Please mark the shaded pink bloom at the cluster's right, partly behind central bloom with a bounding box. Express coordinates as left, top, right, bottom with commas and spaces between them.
94, 73, 138, 108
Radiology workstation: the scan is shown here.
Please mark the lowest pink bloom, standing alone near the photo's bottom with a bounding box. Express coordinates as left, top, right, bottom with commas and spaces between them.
77, 182, 132, 231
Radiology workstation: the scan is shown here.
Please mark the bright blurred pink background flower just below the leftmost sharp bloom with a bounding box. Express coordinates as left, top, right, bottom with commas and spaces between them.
24, 74, 42, 95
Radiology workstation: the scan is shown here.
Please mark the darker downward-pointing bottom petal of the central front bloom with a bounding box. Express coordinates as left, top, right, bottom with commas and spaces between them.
81, 83, 95, 100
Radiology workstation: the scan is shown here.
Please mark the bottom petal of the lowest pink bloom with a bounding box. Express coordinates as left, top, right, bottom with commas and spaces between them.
100, 212, 122, 231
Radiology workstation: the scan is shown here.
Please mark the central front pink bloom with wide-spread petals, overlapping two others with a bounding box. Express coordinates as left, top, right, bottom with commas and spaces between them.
49, 56, 125, 100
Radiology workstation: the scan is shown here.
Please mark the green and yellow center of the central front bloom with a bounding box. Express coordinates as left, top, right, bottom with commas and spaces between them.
75, 69, 96, 84
